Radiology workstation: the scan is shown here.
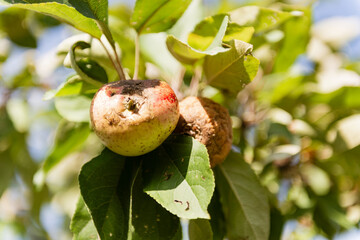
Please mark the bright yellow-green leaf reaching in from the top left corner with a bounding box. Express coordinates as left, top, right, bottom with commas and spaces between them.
0, 0, 102, 39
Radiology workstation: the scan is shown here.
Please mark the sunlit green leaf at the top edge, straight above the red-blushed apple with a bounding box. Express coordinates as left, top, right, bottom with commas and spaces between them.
131, 0, 191, 34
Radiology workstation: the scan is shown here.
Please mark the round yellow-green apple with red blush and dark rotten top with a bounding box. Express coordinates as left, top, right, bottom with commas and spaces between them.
90, 80, 180, 156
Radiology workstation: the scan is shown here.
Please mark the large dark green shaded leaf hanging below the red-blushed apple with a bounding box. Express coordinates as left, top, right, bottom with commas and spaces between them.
79, 149, 181, 239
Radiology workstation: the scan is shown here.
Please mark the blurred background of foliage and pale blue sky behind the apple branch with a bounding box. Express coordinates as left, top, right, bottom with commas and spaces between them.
0, 0, 360, 240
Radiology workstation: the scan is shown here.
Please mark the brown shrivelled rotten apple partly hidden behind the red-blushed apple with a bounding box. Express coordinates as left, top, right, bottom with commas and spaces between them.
175, 97, 232, 167
